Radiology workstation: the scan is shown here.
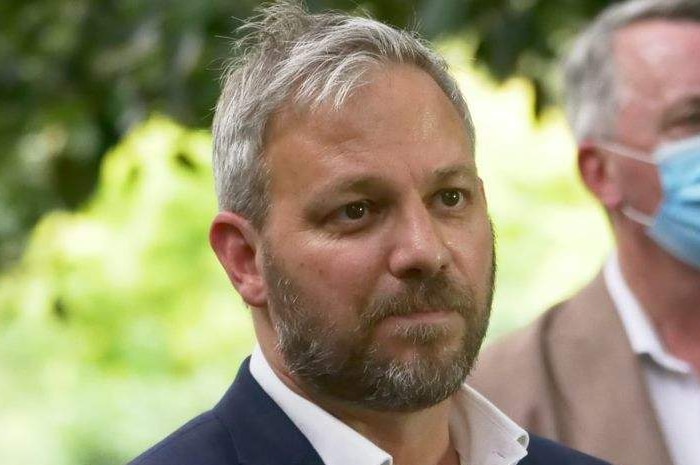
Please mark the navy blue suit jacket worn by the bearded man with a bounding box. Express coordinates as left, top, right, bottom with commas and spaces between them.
131, 360, 606, 465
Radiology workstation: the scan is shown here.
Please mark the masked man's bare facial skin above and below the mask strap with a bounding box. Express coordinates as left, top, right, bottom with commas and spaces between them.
614, 20, 700, 214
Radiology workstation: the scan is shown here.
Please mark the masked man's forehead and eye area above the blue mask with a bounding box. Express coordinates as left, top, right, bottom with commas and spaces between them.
613, 20, 700, 141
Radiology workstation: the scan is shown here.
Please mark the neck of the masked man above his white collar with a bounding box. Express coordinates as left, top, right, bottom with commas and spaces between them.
618, 232, 700, 372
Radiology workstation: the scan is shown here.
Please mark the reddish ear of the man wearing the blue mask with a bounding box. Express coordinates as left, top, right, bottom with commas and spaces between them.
578, 141, 622, 210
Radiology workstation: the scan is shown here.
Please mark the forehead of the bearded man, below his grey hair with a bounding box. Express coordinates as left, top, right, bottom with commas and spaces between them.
264, 65, 474, 197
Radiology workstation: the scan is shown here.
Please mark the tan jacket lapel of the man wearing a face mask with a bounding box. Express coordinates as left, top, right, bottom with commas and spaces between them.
545, 274, 671, 465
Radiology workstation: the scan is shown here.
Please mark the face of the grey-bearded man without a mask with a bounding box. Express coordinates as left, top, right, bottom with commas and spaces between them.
261, 65, 494, 410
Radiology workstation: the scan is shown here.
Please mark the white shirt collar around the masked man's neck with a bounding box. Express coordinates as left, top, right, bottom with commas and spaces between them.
603, 250, 692, 374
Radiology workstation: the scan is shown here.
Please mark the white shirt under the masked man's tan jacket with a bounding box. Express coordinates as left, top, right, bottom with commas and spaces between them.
604, 254, 700, 465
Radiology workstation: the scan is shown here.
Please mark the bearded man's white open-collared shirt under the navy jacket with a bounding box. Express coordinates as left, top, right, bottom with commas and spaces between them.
250, 347, 529, 465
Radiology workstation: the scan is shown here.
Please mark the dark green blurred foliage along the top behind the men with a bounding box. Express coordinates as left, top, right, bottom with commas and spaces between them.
0, 0, 611, 269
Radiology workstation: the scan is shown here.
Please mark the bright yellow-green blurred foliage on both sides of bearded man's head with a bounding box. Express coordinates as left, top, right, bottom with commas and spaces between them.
0, 39, 609, 458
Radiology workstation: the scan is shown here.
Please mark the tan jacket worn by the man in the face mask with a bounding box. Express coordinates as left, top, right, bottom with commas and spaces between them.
467, 274, 672, 465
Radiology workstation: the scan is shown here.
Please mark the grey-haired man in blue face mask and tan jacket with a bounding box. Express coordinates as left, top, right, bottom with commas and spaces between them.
470, 0, 700, 465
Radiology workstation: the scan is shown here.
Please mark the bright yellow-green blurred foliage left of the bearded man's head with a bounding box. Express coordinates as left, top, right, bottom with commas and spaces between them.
0, 117, 253, 465
